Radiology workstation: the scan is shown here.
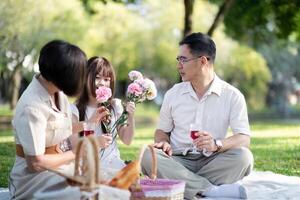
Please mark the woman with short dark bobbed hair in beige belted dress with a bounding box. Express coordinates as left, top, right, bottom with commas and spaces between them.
9, 40, 107, 199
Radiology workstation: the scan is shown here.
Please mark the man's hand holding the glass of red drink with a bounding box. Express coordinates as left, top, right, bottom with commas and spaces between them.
194, 131, 217, 152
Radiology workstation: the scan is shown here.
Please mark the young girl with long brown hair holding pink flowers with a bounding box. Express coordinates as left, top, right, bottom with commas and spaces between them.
72, 57, 135, 169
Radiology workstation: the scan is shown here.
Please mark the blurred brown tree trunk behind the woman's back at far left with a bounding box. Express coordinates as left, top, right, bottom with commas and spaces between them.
9, 63, 22, 109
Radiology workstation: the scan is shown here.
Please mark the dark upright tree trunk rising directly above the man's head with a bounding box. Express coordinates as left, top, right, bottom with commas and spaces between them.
183, 0, 195, 37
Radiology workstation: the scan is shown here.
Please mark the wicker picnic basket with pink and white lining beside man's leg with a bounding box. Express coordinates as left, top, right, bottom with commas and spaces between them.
130, 145, 185, 200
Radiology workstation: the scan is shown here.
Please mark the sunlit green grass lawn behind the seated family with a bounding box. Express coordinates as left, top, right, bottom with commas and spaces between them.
0, 105, 300, 187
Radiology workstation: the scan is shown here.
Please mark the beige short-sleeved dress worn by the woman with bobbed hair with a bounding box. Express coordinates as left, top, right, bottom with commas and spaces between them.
9, 75, 74, 199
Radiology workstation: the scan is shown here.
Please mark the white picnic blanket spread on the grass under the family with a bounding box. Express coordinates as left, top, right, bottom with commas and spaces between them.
0, 171, 300, 200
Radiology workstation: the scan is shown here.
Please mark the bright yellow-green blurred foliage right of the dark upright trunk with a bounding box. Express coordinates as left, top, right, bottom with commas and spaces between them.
193, 1, 271, 110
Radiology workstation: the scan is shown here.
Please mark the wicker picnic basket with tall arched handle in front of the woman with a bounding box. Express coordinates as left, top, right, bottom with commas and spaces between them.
48, 136, 130, 200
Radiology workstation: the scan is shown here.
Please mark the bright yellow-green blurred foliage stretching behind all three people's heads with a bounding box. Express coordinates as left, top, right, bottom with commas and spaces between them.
0, 0, 284, 111
